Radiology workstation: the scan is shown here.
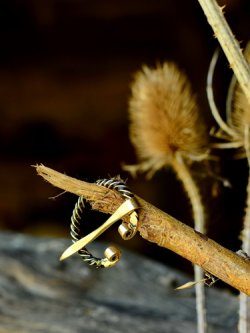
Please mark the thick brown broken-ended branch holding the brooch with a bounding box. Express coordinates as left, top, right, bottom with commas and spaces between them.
36, 165, 250, 296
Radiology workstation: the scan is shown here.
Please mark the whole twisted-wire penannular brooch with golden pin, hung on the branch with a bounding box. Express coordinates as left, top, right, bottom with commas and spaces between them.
60, 178, 138, 268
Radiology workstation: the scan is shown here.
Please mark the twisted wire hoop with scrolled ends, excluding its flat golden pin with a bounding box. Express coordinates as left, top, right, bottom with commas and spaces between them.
70, 178, 138, 268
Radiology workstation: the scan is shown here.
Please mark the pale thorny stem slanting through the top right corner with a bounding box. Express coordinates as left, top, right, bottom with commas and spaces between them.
198, 0, 250, 103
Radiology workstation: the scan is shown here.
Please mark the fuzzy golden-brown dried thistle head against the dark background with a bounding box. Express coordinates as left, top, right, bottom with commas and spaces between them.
126, 63, 207, 175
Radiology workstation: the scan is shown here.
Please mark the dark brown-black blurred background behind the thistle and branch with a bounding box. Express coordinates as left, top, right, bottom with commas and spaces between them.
0, 0, 250, 267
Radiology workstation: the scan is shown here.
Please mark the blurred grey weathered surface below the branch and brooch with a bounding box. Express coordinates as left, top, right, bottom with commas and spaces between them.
0, 233, 238, 333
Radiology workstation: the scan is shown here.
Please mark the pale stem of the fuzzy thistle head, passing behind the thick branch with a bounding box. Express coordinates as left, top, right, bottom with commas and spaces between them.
172, 156, 207, 333
